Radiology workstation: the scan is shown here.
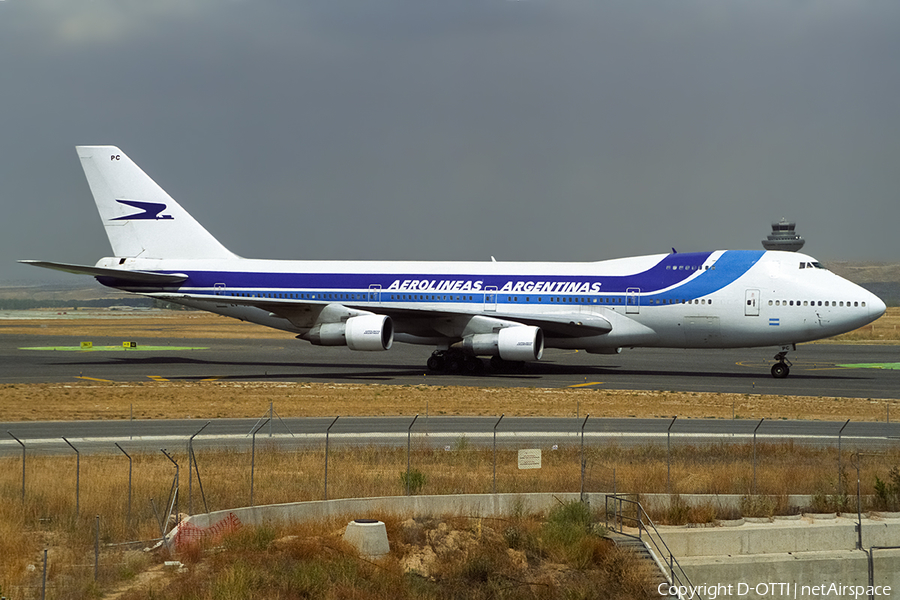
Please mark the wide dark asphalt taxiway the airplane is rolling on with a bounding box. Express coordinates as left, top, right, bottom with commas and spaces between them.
0, 335, 900, 398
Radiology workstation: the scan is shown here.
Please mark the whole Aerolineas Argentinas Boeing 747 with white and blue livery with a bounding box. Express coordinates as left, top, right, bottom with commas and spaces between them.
21, 146, 885, 378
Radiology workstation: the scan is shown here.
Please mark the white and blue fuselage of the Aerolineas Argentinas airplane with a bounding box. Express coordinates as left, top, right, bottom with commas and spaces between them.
97, 250, 885, 352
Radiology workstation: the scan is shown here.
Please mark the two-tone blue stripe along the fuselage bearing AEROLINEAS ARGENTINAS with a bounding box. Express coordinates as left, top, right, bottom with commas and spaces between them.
105, 251, 763, 305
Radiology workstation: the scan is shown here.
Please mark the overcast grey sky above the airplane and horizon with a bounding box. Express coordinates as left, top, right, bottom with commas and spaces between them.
0, 0, 900, 281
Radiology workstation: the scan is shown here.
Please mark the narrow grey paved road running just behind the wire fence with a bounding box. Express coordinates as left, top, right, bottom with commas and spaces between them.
0, 415, 900, 456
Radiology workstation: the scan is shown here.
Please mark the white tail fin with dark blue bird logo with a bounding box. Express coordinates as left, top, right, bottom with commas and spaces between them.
77, 146, 236, 258
